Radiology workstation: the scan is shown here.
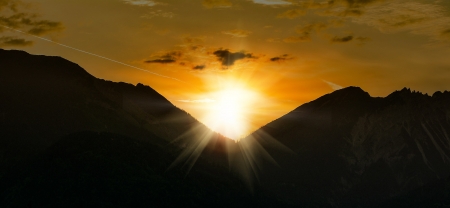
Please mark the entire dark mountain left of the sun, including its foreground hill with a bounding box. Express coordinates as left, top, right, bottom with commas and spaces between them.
0, 49, 278, 207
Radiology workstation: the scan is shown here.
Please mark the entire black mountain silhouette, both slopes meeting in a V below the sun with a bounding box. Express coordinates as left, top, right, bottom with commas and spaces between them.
0, 49, 450, 207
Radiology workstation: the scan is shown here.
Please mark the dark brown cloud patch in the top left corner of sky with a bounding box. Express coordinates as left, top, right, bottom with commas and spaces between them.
0, 0, 64, 46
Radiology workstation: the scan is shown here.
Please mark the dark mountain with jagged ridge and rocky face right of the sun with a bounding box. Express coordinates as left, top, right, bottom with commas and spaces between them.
243, 87, 450, 207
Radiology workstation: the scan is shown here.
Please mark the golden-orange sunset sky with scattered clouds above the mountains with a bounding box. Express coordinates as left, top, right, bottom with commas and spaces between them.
0, 0, 450, 140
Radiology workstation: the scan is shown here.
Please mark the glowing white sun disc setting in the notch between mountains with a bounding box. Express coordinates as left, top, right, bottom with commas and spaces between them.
205, 86, 257, 140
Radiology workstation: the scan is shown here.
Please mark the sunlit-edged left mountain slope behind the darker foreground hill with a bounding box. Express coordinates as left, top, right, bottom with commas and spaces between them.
0, 49, 219, 162
